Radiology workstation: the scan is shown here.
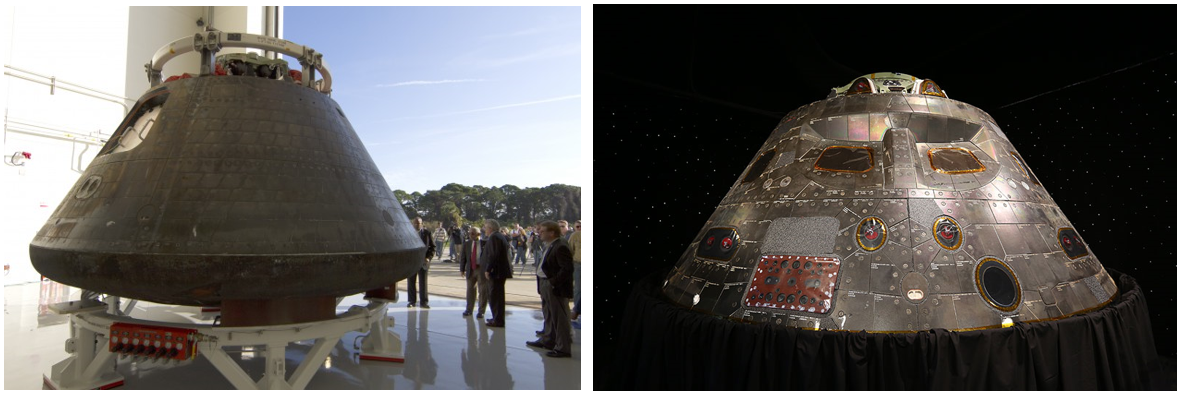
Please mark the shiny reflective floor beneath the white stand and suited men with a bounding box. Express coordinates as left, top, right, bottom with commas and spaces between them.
4, 282, 581, 390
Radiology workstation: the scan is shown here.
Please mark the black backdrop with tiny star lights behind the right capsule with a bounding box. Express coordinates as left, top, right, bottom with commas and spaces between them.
593, 5, 1177, 389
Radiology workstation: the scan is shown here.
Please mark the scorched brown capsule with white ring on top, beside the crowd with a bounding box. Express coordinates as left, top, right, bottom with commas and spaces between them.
29, 32, 424, 325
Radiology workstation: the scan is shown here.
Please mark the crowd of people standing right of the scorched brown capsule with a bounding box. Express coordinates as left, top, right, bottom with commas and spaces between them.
407, 217, 581, 357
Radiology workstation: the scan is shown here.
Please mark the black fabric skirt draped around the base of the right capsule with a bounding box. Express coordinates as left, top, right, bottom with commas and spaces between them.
611, 269, 1164, 390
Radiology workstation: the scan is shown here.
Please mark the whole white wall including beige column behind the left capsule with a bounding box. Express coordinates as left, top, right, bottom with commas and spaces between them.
0, 6, 271, 284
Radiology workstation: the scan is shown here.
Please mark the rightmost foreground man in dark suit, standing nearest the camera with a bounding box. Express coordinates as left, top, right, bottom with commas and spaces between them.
526, 222, 573, 357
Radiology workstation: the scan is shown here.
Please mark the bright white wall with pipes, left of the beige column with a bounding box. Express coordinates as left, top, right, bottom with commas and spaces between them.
0, 6, 129, 284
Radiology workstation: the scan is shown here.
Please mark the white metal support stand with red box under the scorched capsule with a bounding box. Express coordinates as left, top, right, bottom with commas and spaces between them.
45, 299, 404, 389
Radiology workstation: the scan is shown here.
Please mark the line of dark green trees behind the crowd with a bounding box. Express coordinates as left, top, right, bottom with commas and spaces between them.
393, 183, 581, 226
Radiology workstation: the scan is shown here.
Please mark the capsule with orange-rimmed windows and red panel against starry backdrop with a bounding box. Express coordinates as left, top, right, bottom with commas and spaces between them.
663, 73, 1118, 332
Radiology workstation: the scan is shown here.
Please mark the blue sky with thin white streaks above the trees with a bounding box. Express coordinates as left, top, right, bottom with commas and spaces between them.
283, 7, 588, 193
